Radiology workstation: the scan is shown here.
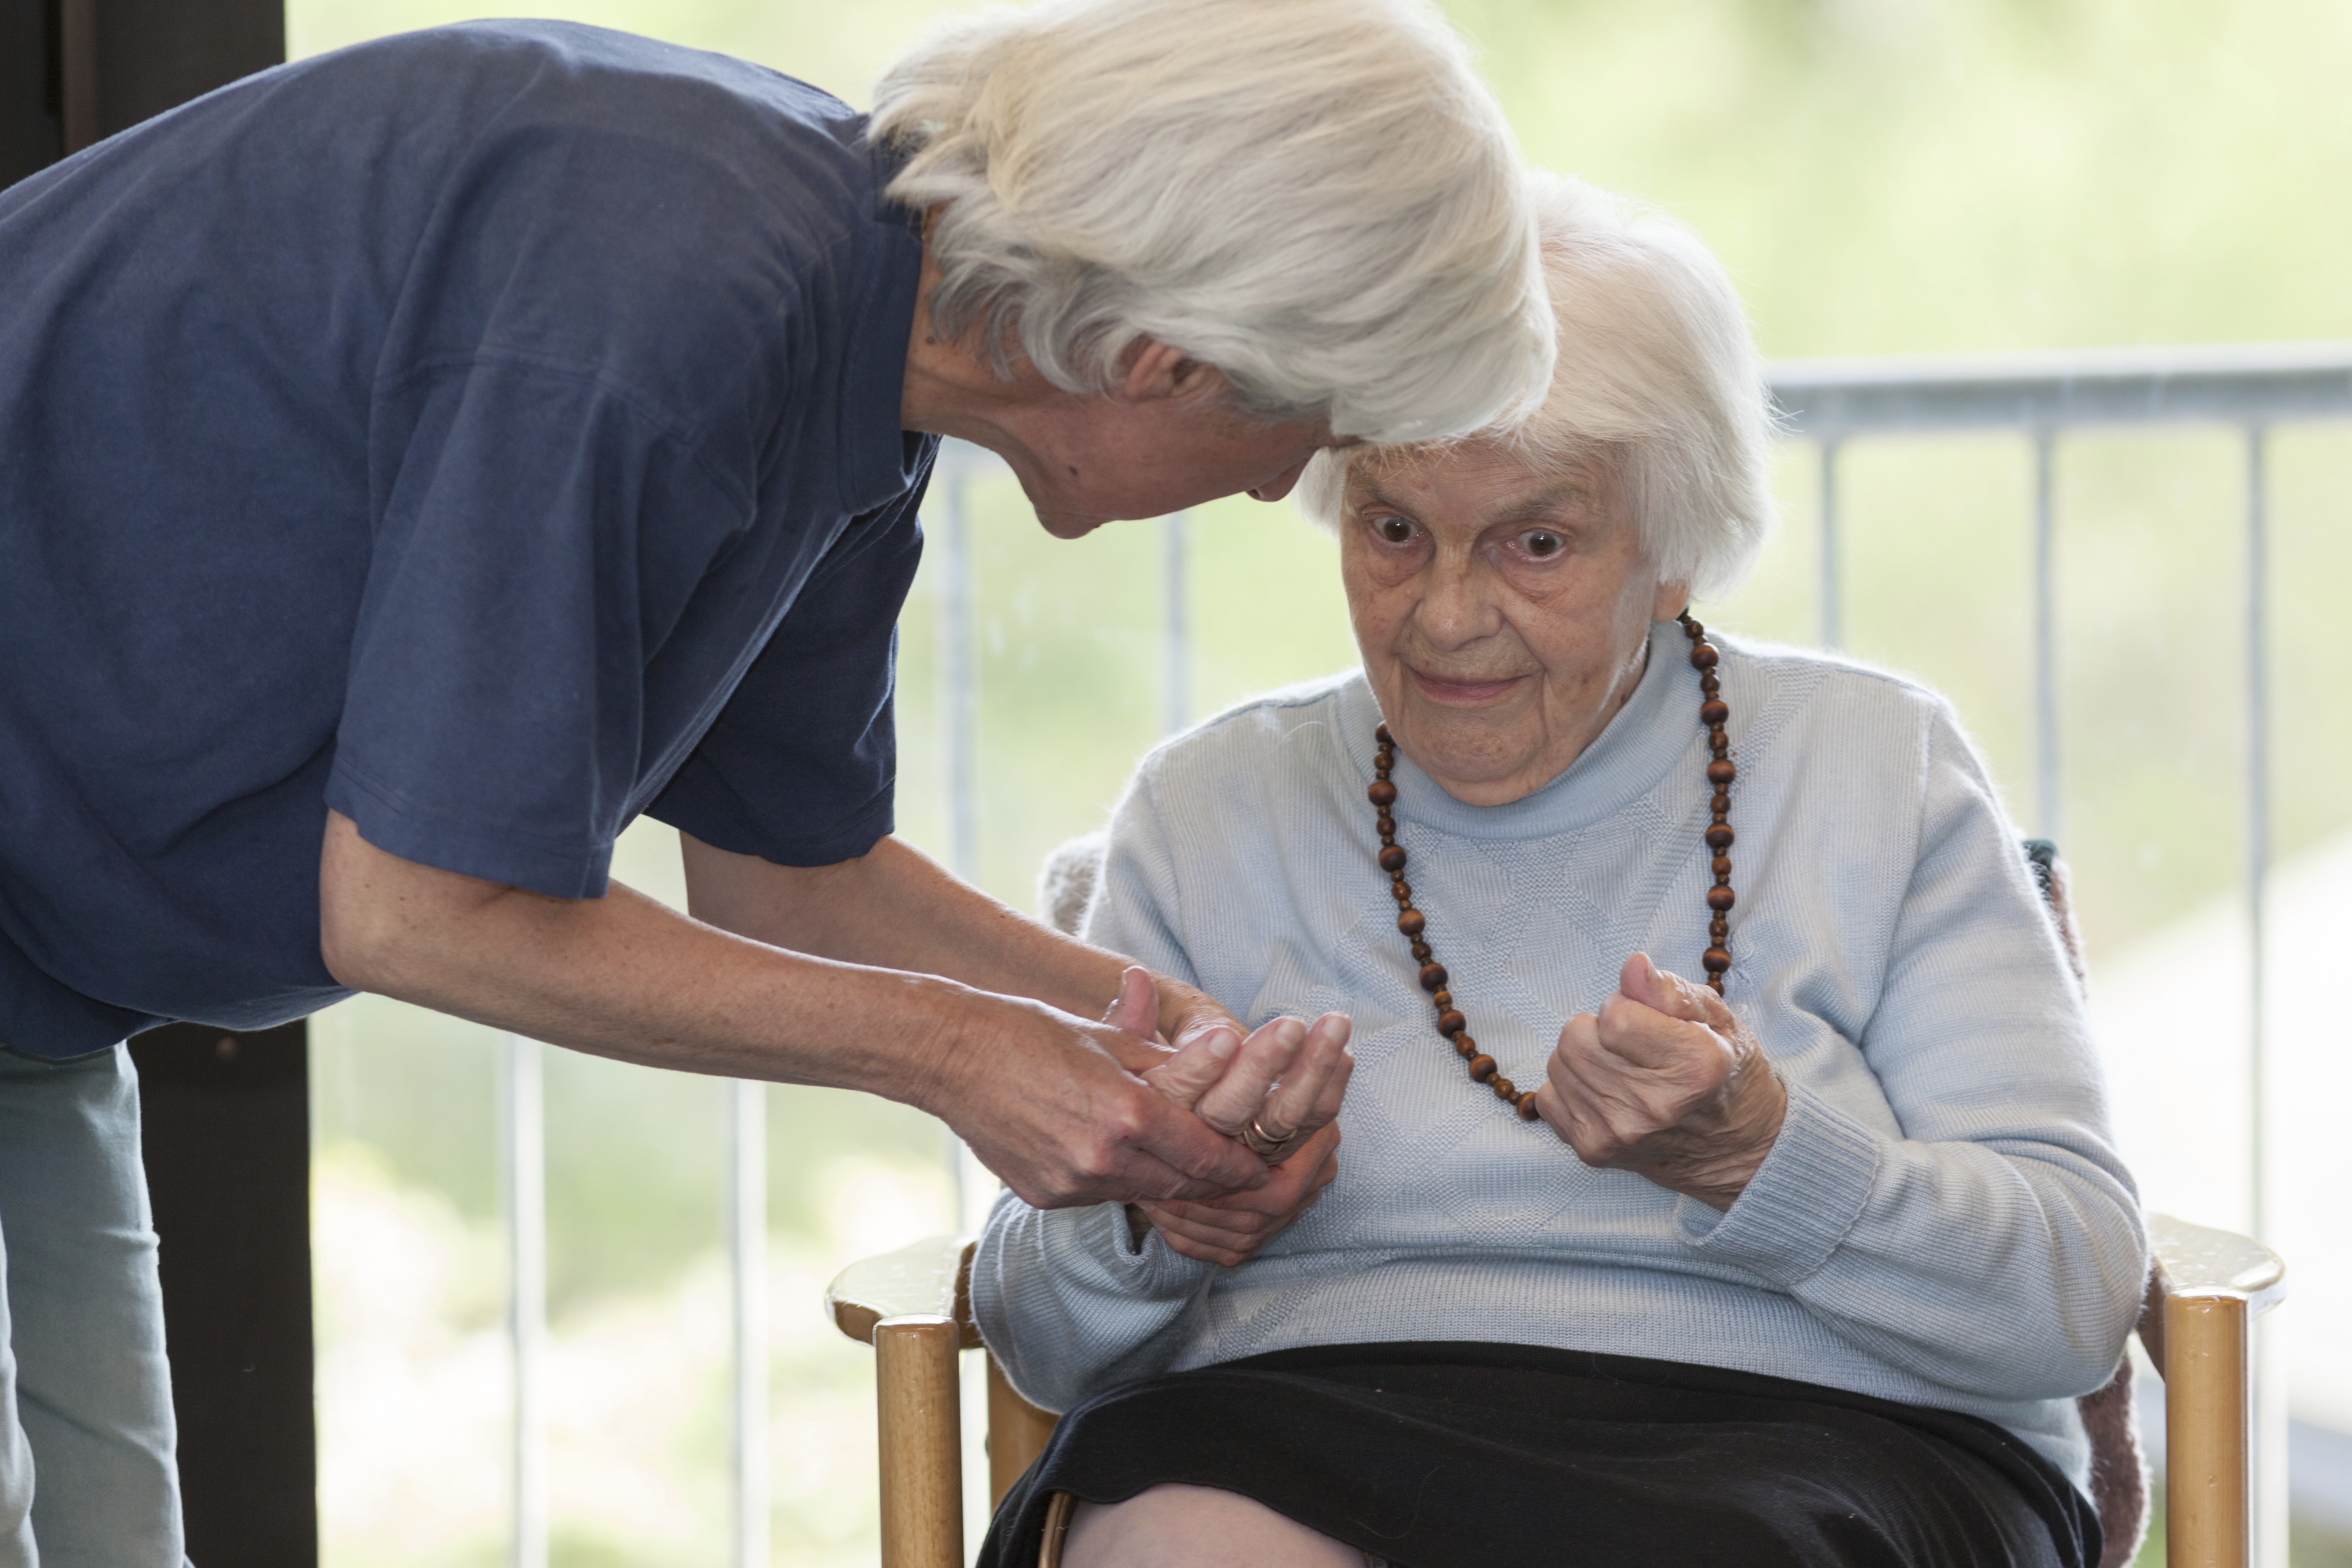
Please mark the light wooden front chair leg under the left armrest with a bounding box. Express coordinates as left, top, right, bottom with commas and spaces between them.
875, 1314, 965, 1568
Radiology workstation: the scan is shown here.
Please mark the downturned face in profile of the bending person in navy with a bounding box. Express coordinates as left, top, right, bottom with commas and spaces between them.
1014, 388, 1343, 538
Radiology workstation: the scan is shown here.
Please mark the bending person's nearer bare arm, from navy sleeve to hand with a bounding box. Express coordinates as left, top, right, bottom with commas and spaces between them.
320, 813, 1265, 1206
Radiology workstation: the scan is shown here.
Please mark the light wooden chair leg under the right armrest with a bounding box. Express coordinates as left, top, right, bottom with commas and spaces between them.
2164, 1295, 2253, 1568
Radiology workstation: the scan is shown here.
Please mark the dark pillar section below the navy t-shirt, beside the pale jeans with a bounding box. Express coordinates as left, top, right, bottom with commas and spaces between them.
132, 1023, 317, 1568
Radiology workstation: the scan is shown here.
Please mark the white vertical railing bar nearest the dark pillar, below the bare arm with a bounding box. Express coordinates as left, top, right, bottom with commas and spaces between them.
499, 1034, 548, 1568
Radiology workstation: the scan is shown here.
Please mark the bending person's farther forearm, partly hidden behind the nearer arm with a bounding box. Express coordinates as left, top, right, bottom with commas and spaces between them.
682, 835, 1127, 1018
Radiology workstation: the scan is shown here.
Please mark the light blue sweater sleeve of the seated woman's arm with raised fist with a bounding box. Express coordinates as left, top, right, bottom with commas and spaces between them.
1677, 705, 2147, 1399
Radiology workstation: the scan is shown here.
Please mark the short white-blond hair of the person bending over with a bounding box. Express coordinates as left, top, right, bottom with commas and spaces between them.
873, 0, 1553, 442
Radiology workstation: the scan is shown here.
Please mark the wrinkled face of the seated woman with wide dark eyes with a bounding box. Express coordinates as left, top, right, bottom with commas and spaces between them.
1341, 447, 1689, 806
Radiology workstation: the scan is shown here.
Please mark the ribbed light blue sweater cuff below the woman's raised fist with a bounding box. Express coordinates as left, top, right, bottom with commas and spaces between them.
1675, 1084, 1879, 1286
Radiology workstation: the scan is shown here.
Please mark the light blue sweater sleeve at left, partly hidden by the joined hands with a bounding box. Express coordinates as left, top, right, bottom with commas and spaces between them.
971, 764, 1216, 1411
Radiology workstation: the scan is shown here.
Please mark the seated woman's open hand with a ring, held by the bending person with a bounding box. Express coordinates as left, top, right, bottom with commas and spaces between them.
1103, 969, 1355, 1267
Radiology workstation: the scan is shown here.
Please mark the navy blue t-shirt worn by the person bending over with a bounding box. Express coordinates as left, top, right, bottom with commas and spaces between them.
0, 23, 936, 1055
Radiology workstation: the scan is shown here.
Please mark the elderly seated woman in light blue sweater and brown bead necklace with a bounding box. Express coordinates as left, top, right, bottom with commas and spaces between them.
971, 181, 2145, 1568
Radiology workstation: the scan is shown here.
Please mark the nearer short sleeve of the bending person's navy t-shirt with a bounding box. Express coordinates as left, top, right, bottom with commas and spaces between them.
327, 355, 750, 898
